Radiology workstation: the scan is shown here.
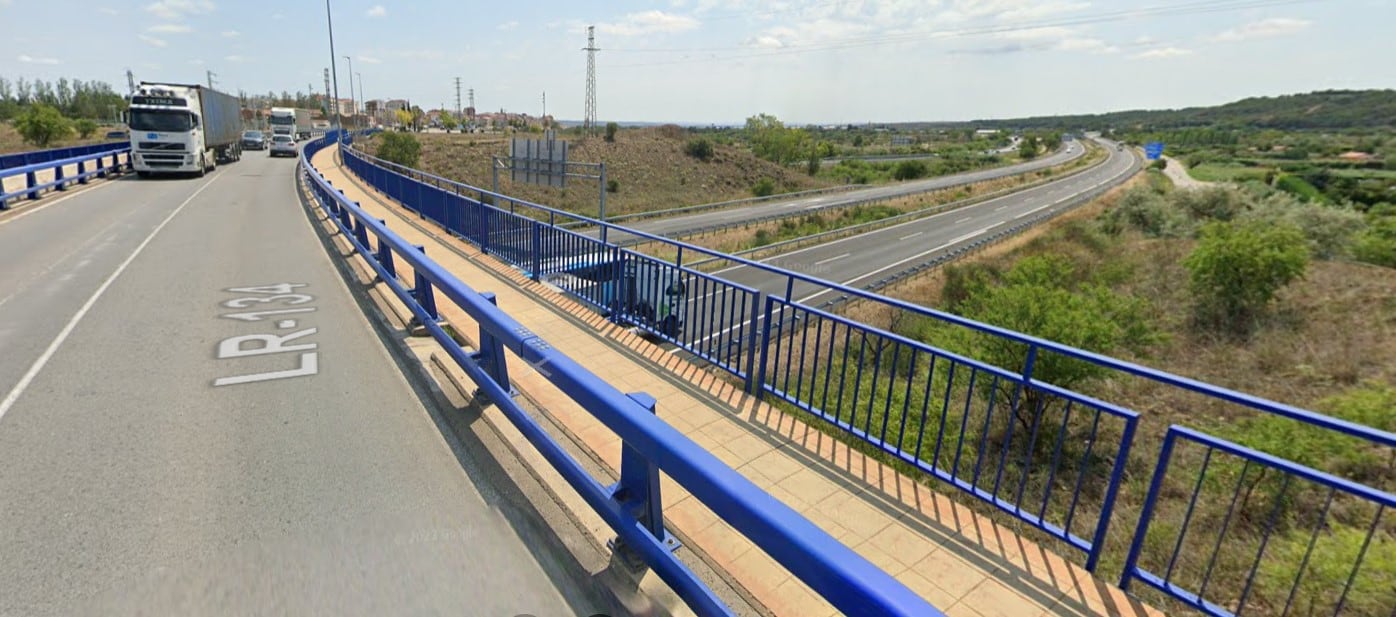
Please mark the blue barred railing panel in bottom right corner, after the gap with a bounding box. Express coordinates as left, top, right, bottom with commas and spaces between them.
1120, 426, 1396, 617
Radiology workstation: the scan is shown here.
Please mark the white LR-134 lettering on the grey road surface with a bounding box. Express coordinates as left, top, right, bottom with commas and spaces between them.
214, 283, 320, 385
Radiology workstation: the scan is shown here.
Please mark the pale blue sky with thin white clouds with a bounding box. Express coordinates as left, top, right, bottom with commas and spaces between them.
0, 0, 1396, 124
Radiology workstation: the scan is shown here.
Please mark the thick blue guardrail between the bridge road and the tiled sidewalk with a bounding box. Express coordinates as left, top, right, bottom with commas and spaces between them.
302, 133, 941, 616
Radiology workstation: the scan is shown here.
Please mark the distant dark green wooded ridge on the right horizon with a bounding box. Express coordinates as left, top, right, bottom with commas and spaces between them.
970, 89, 1396, 130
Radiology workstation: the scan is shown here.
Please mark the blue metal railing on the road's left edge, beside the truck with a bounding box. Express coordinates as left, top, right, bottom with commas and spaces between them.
0, 141, 131, 209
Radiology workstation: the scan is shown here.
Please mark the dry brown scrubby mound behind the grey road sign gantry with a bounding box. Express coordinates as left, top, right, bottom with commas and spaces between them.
367, 127, 831, 215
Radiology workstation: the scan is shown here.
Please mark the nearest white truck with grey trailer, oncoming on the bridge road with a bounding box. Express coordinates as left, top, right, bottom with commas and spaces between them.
127, 81, 243, 177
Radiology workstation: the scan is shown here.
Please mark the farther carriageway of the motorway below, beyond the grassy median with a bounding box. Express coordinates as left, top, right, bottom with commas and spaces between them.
600, 141, 1086, 244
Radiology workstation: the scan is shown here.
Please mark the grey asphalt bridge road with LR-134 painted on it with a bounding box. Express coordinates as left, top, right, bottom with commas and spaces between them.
0, 154, 606, 617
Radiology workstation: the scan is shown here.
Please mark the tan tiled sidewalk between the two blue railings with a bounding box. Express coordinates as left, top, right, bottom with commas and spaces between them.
313, 148, 1161, 617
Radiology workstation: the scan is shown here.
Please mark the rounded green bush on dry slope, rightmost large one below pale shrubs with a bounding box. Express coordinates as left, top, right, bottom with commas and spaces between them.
1182, 222, 1309, 335
